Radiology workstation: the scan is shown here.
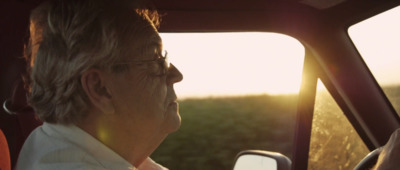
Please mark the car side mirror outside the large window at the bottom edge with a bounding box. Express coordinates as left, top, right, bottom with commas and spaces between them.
233, 150, 292, 170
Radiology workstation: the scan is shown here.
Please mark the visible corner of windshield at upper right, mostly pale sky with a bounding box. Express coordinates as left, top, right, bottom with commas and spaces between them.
348, 7, 400, 114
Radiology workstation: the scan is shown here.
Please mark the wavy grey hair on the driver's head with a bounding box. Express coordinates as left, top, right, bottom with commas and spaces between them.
25, 0, 159, 124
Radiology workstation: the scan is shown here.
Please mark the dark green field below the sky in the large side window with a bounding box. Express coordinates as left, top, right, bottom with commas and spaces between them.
152, 95, 297, 170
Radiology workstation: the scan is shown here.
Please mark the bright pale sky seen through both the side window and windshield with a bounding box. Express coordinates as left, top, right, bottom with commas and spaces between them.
161, 7, 400, 98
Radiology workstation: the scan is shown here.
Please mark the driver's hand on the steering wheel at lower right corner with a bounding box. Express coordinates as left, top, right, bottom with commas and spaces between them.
374, 129, 400, 170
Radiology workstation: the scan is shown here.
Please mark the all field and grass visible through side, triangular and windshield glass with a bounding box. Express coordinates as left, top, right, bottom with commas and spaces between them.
152, 87, 400, 170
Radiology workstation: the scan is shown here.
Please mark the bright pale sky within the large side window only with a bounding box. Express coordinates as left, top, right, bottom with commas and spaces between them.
161, 33, 304, 98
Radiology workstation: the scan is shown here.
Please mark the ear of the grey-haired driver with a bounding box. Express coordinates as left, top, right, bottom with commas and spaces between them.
81, 68, 115, 114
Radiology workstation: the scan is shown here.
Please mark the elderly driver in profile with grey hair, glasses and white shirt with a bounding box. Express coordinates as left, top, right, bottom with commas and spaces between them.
17, 0, 182, 170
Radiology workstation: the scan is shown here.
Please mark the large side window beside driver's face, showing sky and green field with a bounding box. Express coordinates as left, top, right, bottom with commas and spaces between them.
152, 33, 305, 169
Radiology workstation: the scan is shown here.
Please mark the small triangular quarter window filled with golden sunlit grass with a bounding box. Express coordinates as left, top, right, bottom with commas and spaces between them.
308, 81, 369, 169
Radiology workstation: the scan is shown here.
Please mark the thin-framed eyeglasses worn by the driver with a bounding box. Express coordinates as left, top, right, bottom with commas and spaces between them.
115, 50, 170, 76
